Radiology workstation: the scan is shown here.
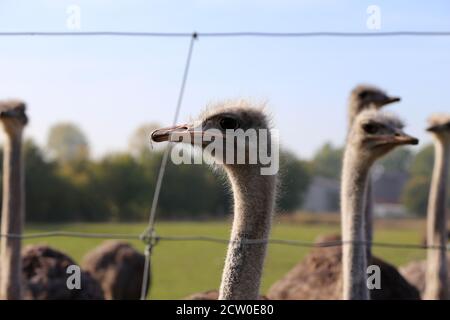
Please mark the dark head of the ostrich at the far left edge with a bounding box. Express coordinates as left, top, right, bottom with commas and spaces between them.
0, 100, 28, 136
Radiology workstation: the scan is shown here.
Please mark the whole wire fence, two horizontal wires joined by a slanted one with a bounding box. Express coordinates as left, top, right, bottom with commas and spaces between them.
0, 31, 450, 300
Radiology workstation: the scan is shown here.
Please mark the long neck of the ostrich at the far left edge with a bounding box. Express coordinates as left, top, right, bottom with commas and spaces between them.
0, 134, 24, 300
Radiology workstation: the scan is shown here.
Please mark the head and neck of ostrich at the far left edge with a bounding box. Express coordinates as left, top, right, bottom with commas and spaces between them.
0, 100, 28, 300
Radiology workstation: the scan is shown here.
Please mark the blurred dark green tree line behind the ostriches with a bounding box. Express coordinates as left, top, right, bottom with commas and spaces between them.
0, 123, 442, 222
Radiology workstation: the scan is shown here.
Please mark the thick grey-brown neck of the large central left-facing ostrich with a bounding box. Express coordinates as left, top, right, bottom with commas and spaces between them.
219, 168, 276, 300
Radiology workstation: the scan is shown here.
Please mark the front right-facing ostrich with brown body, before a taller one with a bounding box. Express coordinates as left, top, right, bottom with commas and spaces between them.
267, 110, 420, 300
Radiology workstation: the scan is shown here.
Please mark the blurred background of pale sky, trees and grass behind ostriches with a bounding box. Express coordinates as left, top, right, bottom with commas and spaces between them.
0, 0, 450, 298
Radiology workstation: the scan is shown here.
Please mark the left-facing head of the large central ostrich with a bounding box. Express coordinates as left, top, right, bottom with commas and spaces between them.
151, 100, 277, 175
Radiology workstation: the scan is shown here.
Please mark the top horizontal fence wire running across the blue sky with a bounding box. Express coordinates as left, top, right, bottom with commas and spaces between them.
0, 31, 450, 38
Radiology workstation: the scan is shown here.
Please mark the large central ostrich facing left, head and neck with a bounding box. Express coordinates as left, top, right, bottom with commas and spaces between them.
152, 100, 277, 300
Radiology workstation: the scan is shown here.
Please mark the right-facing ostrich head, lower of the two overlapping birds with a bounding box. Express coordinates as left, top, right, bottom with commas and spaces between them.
349, 110, 419, 164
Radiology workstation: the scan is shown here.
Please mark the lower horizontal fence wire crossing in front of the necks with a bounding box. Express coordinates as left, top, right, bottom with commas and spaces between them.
0, 231, 450, 251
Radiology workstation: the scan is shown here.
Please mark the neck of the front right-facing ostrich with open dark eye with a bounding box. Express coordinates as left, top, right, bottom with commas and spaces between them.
341, 148, 370, 300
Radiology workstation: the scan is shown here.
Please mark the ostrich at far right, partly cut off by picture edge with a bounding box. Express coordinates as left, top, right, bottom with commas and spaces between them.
402, 115, 450, 300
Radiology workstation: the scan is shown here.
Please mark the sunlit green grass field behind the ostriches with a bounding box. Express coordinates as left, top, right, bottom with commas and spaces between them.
25, 221, 424, 299
